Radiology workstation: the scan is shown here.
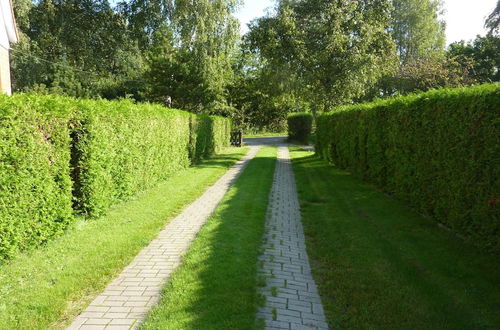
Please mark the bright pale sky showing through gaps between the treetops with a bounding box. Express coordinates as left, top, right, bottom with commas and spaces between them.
236, 0, 497, 44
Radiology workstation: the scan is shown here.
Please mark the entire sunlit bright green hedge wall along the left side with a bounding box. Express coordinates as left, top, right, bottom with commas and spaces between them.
0, 94, 231, 260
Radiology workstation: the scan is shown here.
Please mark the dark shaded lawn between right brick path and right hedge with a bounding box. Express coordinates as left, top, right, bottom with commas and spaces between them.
292, 149, 500, 329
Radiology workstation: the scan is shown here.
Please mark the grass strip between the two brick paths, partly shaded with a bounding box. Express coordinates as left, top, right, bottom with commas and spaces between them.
141, 147, 276, 330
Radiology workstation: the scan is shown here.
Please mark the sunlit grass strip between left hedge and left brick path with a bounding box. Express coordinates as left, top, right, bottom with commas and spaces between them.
0, 149, 248, 330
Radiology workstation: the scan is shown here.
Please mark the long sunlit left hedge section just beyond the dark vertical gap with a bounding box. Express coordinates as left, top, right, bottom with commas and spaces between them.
73, 101, 191, 216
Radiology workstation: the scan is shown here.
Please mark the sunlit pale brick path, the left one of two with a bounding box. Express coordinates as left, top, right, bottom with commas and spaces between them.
69, 146, 259, 330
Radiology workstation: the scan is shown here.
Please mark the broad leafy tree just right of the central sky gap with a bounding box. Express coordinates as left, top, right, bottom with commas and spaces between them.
248, 0, 394, 110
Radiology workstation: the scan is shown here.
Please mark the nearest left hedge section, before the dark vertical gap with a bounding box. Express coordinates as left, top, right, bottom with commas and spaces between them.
0, 95, 74, 260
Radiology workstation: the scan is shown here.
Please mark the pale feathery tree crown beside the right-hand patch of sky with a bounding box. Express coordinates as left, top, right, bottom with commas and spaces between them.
391, 0, 446, 65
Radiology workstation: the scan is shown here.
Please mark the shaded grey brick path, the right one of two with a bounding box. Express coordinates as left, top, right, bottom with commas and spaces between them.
257, 146, 328, 329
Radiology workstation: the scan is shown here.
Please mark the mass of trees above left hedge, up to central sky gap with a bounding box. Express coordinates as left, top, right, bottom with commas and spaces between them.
12, 0, 239, 114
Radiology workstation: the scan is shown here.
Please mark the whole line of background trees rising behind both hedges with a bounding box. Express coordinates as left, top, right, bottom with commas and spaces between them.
12, 0, 500, 130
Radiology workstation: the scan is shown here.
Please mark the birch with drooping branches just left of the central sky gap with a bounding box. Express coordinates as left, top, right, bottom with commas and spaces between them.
147, 0, 239, 115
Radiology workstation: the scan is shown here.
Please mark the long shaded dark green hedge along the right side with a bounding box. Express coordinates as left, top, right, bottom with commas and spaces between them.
316, 85, 500, 252
